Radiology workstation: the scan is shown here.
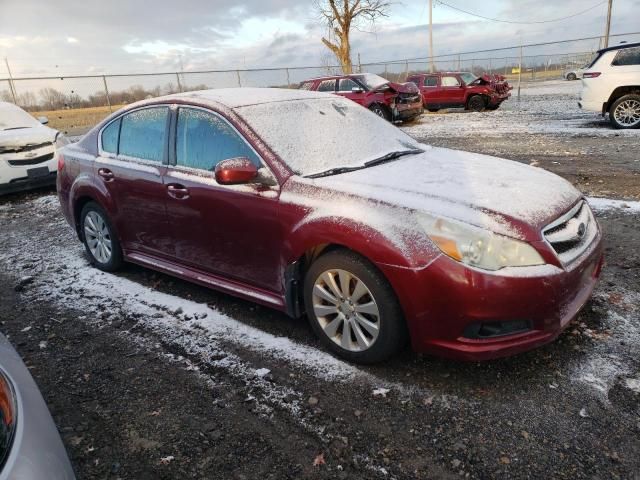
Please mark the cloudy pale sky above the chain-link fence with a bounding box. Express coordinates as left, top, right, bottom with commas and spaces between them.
0, 0, 640, 77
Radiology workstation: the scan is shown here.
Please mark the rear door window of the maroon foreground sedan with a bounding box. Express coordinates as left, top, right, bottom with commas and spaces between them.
118, 107, 169, 162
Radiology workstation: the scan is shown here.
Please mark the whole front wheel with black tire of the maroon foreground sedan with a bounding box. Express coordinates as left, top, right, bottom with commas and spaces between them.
304, 250, 408, 364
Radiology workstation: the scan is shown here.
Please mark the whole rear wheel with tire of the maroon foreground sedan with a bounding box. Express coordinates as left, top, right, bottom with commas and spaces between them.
80, 202, 124, 272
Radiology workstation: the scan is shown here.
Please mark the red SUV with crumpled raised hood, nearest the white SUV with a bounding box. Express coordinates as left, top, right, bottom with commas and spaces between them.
407, 72, 513, 112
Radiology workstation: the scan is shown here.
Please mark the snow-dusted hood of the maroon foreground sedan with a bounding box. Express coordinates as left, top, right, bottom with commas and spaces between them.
308, 147, 582, 240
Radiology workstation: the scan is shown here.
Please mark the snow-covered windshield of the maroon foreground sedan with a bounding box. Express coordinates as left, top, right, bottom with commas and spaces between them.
236, 98, 421, 175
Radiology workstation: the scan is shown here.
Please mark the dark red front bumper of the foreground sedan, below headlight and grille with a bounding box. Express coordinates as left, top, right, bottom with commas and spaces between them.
379, 234, 603, 361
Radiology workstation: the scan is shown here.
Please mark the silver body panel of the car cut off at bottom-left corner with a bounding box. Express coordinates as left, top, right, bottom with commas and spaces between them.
0, 334, 75, 480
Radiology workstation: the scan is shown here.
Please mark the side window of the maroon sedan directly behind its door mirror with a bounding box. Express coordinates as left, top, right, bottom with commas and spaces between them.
176, 108, 260, 171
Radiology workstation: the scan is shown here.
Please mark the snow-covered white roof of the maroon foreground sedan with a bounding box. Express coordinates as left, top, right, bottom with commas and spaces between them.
149, 87, 335, 108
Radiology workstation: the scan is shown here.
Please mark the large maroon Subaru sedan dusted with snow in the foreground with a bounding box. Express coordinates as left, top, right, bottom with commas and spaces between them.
58, 88, 602, 362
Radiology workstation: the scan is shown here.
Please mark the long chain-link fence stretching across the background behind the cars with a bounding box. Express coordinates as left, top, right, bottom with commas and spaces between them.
0, 32, 640, 134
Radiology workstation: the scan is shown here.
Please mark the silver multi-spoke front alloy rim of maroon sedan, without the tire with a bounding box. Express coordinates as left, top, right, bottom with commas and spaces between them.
312, 269, 380, 352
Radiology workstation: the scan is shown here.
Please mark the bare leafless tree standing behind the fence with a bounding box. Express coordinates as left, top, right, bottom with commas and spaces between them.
314, 0, 391, 73
